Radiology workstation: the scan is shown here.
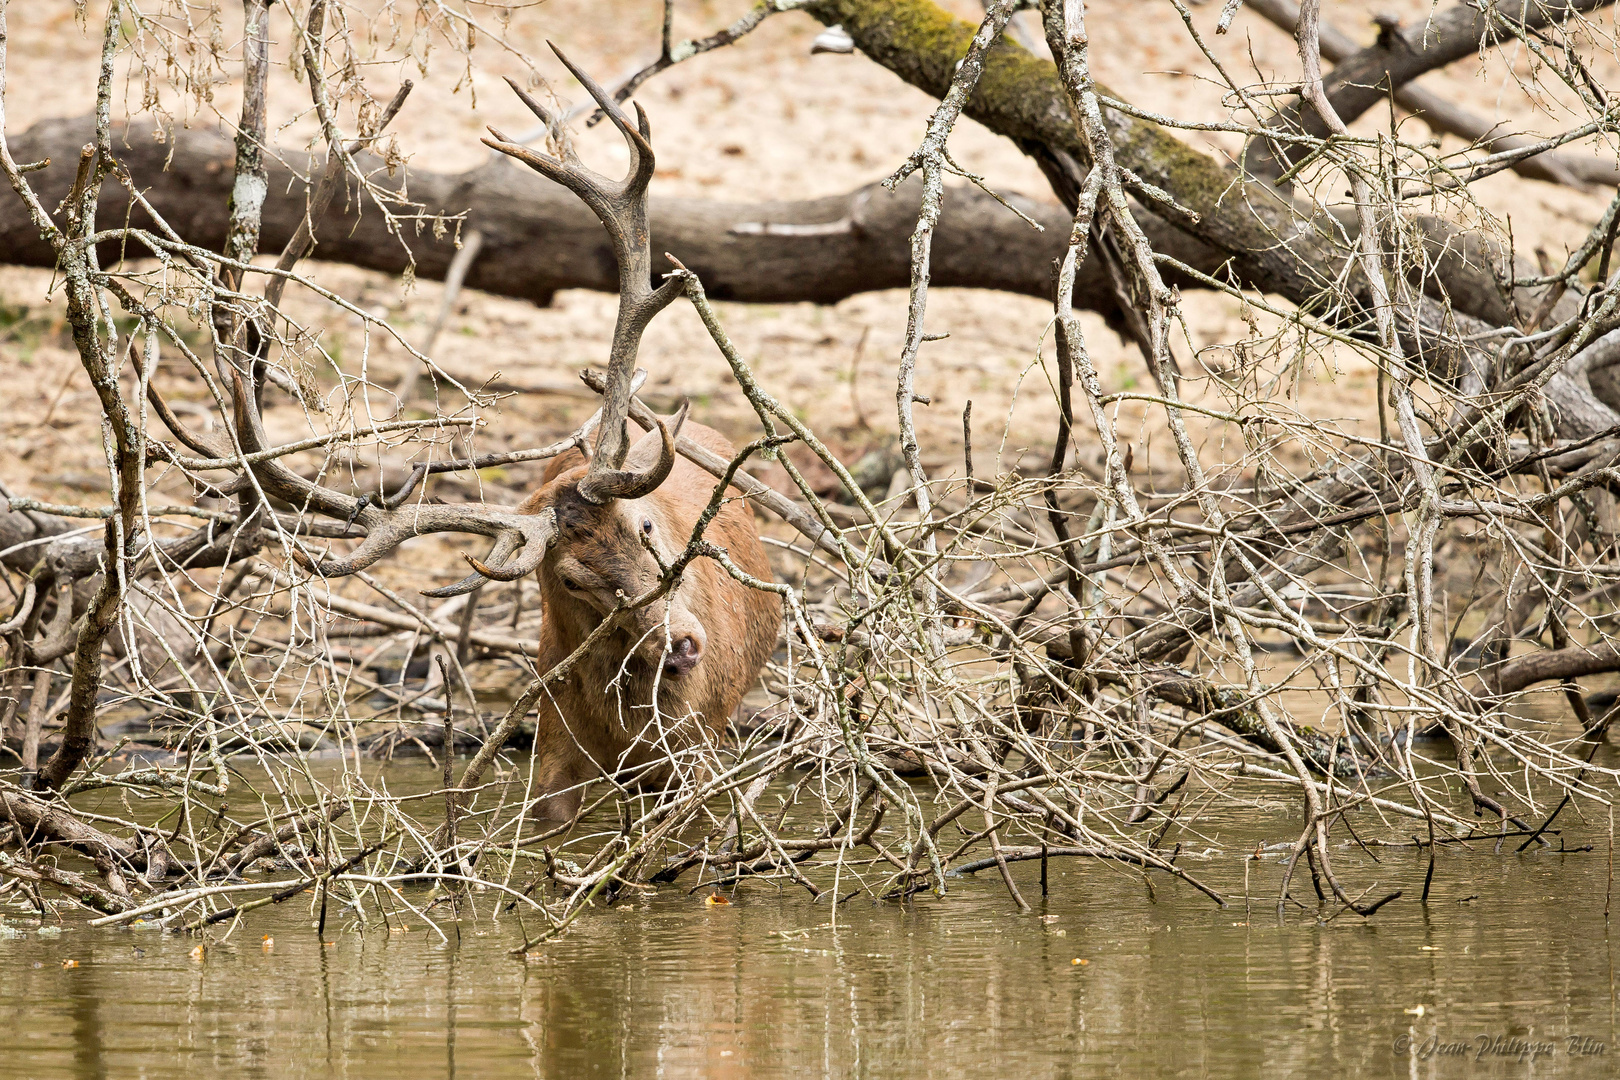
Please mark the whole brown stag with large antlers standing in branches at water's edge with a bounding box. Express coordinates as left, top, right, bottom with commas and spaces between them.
267, 45, 784, 821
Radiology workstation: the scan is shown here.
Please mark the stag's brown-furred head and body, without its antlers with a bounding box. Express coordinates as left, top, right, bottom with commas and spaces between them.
522, 423, 781, 821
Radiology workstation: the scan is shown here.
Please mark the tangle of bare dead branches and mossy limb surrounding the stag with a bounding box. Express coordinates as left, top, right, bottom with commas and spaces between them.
0, 0, 1620, 947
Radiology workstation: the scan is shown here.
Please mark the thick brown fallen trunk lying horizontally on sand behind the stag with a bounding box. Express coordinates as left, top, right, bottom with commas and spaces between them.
0, 117, 1220, 313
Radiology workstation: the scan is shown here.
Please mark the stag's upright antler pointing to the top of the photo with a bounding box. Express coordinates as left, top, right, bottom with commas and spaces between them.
483, 42, 682, 478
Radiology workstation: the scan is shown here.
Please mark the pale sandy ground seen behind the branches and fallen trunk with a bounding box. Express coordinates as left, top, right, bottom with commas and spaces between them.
0, 0, 1617, 592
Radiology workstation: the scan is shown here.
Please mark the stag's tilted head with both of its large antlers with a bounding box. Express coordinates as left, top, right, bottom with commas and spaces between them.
149, 45, 735, 693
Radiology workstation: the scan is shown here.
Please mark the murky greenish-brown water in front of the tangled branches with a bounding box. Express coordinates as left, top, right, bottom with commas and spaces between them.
0, 764, 1620, 1080
